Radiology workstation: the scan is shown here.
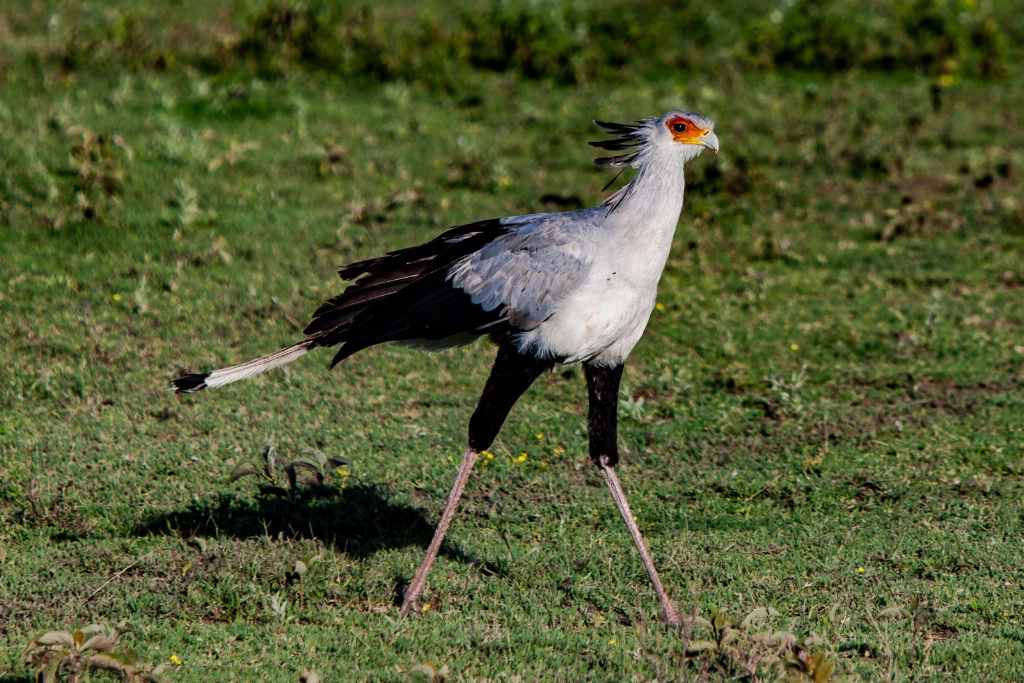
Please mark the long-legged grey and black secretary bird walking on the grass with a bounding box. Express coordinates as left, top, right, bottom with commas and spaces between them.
174, 111, 718, 626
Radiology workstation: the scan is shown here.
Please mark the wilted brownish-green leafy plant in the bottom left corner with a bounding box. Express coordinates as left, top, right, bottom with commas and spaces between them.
23, 624, 172, 683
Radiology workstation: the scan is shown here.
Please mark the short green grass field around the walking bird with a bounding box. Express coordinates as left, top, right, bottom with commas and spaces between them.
0, 1, 1024, 683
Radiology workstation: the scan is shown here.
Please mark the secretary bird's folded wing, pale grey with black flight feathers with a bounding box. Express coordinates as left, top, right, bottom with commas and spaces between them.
305, 214, 588, 365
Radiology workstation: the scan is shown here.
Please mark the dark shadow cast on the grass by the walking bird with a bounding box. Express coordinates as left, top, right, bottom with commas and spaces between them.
133, 484, 506, 590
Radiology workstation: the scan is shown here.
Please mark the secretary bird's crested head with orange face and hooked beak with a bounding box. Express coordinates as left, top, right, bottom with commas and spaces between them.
591, 111, 718, 166
